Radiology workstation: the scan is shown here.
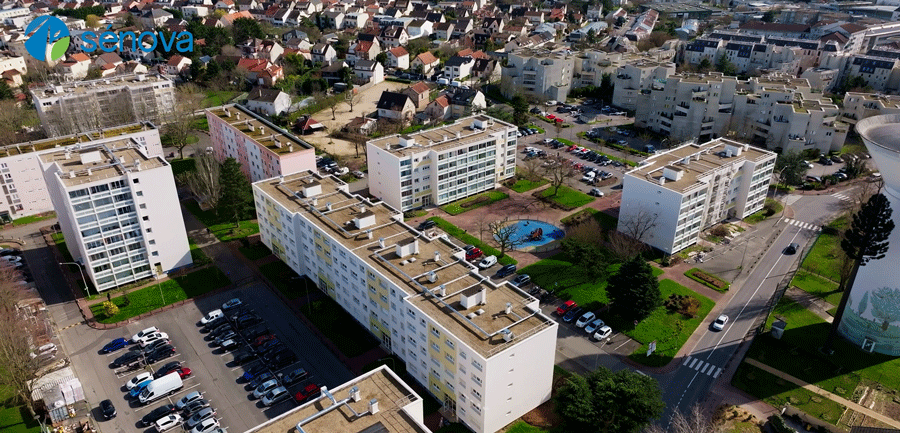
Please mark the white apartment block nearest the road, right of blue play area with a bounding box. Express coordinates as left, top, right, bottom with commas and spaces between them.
619, 138, 776, 254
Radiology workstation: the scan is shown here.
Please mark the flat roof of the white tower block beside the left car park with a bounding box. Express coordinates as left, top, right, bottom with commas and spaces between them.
40, 140, 168, 186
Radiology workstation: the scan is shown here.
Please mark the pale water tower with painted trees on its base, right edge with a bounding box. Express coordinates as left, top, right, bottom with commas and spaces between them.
838, 114, 900, 356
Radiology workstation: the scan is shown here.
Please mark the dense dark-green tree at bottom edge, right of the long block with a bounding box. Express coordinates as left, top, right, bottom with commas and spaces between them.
556, 367, 665, 433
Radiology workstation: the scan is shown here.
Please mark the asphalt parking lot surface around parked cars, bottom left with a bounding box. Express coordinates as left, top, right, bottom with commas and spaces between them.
62, 286, 353, 432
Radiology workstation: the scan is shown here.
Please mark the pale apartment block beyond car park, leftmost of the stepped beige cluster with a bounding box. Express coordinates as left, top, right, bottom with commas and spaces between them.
500, 48, 575, 101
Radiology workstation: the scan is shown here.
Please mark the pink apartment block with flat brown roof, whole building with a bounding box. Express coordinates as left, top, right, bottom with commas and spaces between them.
206, 105, 316, 182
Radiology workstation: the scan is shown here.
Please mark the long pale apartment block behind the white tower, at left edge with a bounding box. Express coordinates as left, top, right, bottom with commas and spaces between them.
0, 122, 163, 221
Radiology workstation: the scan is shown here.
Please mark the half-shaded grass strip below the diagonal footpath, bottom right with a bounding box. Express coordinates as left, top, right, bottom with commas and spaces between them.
731, 364, 844, 424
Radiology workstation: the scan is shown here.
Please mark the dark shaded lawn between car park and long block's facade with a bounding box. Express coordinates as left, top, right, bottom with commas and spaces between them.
300, 297, 378, 358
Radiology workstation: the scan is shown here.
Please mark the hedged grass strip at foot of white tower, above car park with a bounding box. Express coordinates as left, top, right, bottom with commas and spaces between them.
91, 268, 230, 323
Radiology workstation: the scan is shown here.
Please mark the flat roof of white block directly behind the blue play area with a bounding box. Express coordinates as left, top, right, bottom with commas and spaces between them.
368, 115, 516, 157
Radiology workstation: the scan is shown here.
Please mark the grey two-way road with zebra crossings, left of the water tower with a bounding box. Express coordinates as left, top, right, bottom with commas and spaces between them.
655, 191, 850, 423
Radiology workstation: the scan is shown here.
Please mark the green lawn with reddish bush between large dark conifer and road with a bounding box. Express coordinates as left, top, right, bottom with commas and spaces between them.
624, 279, 715, 367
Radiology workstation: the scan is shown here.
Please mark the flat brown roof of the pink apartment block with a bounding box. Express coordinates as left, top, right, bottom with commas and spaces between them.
206, 104, 313, 155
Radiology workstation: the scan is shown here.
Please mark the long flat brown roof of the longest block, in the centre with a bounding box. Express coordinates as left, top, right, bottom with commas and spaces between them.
254, 172, 553, 357
